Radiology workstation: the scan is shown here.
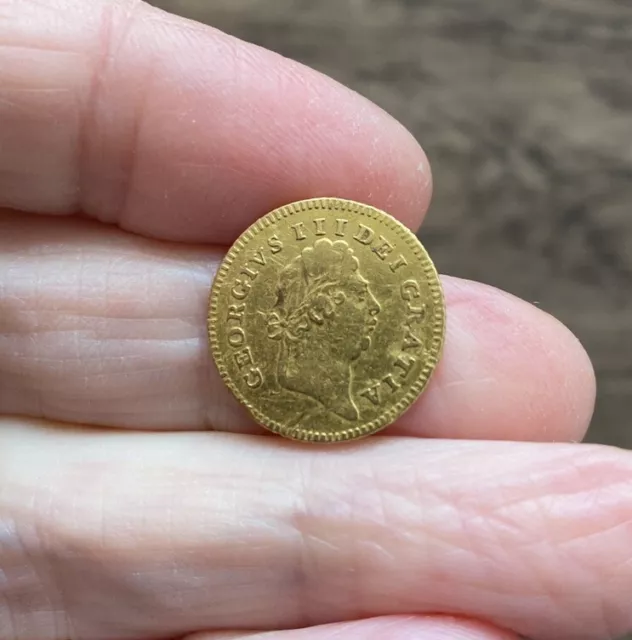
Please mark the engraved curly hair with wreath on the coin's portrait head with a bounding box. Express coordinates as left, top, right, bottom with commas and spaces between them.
268, 238, 359, 342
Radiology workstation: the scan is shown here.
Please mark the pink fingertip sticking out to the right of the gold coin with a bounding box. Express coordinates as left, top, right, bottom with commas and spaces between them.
399, 277, 595, 442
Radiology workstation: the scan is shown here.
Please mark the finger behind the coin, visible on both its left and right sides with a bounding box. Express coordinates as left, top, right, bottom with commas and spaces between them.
0, 214, 594, 440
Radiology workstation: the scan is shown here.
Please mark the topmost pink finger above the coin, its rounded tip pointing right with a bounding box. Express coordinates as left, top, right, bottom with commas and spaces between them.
0, 0, 431, 243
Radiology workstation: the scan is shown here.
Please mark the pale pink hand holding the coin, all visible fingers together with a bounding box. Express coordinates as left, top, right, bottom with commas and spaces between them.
0, 0, 632, 640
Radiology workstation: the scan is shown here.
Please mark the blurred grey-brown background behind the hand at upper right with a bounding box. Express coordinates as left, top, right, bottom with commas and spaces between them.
153, 0, 632, 456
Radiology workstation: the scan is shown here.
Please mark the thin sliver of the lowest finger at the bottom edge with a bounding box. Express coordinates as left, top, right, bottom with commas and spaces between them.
184, 616, 516, 640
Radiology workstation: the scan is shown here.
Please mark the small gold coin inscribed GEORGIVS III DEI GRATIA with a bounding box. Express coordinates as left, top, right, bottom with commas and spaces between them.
208, 198, 445, 442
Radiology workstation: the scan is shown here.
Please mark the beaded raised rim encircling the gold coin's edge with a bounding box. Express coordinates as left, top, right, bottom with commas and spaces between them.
208, 198, 446, 443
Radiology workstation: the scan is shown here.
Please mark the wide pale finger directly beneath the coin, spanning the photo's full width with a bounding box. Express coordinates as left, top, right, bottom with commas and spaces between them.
0, 420, 632, 640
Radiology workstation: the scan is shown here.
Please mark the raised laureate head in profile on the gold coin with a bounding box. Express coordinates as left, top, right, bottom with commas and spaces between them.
267, 238, 381, 421
